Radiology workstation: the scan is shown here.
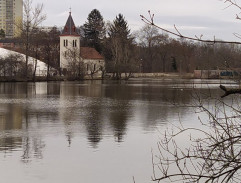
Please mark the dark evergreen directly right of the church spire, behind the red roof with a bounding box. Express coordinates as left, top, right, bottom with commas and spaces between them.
83, 9, 105, 52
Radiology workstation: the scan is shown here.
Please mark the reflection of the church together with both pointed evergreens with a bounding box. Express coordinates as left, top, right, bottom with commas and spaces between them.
60, 81, 130, 147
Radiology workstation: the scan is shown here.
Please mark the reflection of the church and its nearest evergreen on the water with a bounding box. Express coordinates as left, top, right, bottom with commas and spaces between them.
59, 81, 104, 147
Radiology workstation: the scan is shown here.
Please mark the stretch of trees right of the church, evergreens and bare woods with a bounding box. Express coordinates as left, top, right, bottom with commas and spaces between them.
80, 9, 241, 78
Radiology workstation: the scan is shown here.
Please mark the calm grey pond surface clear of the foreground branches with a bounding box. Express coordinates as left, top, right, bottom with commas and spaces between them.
0, 79, 235, 183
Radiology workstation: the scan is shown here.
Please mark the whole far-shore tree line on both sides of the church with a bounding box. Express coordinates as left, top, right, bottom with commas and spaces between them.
1, 3, 241, 79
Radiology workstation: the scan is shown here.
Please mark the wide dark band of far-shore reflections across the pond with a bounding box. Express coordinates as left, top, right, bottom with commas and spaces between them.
0, 80, 226, 159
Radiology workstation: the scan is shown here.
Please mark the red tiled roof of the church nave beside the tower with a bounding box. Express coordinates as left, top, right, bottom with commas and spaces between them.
80, 47, 104, 59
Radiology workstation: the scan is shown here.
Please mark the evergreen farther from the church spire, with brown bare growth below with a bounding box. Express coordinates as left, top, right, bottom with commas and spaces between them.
105, 14, 138, 79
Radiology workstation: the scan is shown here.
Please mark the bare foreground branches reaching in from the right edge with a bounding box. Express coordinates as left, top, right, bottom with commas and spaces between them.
141, 0, 241, 183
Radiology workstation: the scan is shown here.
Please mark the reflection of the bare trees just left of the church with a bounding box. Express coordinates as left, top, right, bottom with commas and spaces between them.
22, 83, 60, 163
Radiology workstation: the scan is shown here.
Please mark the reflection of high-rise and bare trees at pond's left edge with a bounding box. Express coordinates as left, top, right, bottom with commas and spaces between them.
0, 83, 59, 163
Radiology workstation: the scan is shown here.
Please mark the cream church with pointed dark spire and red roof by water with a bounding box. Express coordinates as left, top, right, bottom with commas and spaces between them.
60, 12, 105, 78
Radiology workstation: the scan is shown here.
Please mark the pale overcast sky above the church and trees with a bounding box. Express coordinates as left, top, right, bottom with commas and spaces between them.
33, 0, 241, 41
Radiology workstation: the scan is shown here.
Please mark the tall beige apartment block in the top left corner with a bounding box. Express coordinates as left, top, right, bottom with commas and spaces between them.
0, 0, 23, 38
